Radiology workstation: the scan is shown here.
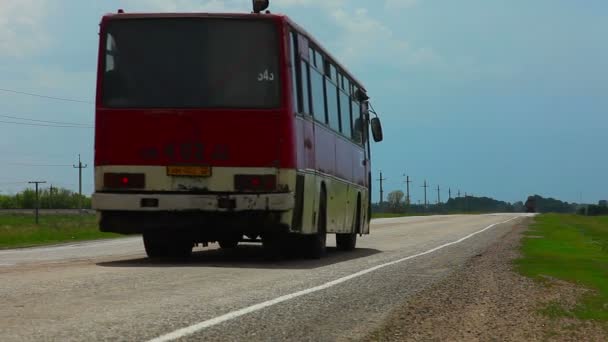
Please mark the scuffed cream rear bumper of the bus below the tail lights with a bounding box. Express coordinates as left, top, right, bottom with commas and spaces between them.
92, 193, 295, 212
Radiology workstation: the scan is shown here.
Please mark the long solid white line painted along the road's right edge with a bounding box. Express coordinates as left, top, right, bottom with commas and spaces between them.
148, 216, 521, 342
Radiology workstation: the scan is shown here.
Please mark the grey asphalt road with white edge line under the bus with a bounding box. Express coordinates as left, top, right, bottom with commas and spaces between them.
0, 214, 522, 341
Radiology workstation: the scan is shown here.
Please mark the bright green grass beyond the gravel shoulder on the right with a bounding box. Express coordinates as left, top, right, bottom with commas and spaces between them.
516, 214, 608, 322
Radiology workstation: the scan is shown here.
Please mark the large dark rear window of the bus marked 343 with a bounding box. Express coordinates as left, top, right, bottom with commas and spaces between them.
103, 18, 280, 108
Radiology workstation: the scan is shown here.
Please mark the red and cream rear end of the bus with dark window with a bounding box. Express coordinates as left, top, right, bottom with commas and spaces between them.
93, 14, 296, 257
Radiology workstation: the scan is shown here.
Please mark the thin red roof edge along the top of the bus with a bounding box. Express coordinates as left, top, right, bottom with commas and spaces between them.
101, 13, 366, 92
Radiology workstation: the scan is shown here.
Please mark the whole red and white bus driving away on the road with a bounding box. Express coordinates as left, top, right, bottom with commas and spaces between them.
93, 5, 382, 258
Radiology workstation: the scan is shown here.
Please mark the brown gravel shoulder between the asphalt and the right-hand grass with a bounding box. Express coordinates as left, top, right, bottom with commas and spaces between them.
366, 219, 608, 341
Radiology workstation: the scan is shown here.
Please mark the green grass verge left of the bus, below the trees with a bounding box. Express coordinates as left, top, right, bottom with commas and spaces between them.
0, 214, 119, 249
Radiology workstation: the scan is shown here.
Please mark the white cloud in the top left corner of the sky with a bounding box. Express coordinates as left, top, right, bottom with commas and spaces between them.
0, 0, 49, 57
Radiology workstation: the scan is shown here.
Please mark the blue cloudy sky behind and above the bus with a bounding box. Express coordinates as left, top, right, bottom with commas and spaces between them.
0, 0, 608, 203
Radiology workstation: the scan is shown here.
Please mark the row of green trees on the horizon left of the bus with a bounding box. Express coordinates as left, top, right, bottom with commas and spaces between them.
0, 188, 91, 209
